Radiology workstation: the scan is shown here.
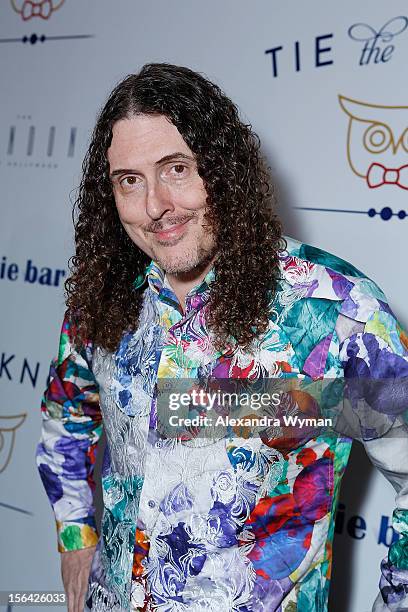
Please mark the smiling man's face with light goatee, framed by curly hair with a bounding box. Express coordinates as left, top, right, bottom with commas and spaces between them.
108, 115, 215, 274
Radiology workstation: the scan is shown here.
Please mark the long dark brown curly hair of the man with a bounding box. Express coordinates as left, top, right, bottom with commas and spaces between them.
65, 64, 284, 351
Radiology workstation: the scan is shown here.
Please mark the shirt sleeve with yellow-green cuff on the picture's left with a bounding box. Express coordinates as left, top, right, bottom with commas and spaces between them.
36, 313, 102, 552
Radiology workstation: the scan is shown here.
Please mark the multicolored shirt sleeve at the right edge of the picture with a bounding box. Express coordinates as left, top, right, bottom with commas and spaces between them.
339, 284, 408, 612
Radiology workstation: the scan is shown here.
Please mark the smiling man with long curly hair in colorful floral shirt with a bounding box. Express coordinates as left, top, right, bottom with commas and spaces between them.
37, 64, 408, 612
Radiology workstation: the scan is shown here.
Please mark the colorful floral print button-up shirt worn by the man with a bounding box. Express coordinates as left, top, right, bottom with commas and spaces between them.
37, 238, 408, 612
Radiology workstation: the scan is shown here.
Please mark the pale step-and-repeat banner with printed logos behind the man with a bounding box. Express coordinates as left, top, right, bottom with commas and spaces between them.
0, 0, 408, 612
